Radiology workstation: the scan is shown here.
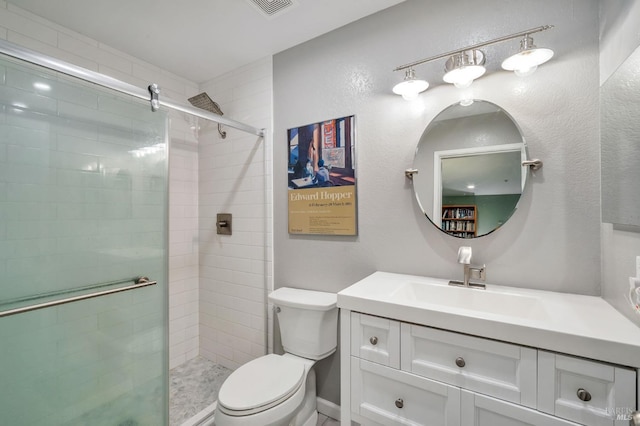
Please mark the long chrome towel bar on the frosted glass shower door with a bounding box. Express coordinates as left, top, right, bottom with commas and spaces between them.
0, 277, 158, 318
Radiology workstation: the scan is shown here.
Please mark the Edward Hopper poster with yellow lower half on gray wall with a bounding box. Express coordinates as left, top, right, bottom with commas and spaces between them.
287, 115, 358, 235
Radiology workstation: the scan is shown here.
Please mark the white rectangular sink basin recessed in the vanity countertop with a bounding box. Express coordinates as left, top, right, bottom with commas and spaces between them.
390, 281, 548, 320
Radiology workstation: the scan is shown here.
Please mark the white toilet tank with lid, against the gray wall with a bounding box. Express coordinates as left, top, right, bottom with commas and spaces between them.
269, 287, 338, 360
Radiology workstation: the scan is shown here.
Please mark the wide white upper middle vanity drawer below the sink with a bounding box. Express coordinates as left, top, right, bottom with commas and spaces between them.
401, 324, 537, 408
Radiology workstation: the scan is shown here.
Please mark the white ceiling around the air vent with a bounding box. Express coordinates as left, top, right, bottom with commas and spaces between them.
7, 0, 404, 83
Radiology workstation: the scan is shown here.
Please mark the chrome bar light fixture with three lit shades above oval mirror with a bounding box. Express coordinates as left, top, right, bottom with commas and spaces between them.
393, 25, 553, 100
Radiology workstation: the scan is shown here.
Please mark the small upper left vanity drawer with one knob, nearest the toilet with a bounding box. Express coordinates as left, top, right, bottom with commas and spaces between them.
351, 312, 400, 368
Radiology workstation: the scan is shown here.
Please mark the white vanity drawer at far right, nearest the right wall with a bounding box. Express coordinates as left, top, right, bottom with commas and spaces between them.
538, 351, 636, 426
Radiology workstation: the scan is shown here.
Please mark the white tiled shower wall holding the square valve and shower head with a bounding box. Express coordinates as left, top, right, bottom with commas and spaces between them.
199, 58, 272, 368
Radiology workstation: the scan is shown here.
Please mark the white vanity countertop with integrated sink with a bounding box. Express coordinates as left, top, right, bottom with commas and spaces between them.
338, 272, 640, 368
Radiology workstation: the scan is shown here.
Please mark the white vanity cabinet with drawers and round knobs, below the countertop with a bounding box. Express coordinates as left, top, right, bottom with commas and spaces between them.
341, 309, 637, 426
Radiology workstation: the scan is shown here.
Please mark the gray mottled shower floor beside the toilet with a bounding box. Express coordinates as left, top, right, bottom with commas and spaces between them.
169, 357, 232, 426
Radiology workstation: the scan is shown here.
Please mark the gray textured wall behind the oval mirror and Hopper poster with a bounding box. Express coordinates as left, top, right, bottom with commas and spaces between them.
273, 0, 600, 403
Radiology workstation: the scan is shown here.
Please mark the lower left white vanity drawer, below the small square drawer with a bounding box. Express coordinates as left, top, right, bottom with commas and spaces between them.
351, 357, 460, 426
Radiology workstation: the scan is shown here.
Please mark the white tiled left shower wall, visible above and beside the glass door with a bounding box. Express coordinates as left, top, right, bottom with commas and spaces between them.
0, 0, 198, 365
